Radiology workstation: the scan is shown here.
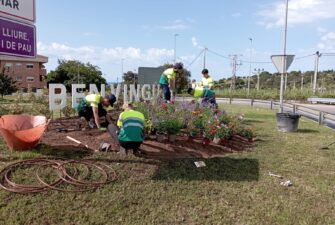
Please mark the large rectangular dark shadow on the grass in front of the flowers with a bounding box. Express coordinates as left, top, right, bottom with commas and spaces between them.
152, 157, 259, 181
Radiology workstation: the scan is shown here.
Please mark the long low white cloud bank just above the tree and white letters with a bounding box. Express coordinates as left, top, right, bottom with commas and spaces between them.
37, 42, 174, 80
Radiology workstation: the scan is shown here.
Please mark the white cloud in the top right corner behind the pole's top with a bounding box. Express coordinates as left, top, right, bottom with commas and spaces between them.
257, 0, 335, 28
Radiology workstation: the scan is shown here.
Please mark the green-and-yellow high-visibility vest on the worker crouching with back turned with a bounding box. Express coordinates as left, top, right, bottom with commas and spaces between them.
117, 110, 145, 142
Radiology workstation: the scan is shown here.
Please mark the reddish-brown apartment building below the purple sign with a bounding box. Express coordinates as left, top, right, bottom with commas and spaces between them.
0, 55, 48, 92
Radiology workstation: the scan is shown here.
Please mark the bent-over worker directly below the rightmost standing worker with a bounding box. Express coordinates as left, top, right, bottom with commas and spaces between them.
187, 87, 218, 108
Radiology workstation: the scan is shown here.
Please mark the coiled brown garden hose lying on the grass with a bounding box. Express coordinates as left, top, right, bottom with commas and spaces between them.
0, 158, 117, 194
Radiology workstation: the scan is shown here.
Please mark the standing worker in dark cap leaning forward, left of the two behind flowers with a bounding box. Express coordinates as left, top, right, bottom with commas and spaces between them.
159, 63, 184, 103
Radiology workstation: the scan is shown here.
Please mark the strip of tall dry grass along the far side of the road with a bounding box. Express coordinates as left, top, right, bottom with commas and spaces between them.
215, 89, 335, 101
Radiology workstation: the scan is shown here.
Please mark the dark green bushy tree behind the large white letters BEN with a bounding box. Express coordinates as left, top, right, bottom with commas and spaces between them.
47, 60, 106, 91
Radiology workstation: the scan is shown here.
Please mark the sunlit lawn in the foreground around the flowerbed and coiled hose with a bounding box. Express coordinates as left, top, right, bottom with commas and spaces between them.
0, 105, 335, 225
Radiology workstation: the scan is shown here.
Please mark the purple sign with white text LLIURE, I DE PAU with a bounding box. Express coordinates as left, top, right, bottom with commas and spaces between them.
0, 16, 36, 57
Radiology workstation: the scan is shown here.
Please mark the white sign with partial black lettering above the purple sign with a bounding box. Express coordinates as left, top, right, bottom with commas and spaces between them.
0, 0, 36, 23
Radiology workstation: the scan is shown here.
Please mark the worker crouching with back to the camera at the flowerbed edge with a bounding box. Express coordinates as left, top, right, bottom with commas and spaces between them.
117, 103, 145, 156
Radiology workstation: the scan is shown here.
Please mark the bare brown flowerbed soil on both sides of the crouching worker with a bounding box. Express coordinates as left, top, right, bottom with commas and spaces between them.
41, 118, 254, 159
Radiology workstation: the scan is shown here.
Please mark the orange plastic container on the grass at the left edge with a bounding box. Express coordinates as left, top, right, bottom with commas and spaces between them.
0, 115, 48, 151
